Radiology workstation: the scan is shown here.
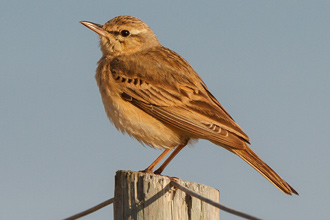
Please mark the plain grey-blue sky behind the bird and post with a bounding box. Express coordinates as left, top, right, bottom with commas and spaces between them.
0, 0, 330, 220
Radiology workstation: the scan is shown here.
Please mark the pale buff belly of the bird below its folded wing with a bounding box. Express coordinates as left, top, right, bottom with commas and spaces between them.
101, 91, 189, 148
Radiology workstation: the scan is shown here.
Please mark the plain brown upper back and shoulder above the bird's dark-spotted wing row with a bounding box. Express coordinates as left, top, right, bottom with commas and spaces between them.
110, 46, 201, 89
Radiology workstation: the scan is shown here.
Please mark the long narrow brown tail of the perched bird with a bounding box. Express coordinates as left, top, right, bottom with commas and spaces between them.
229, 144, 298, 195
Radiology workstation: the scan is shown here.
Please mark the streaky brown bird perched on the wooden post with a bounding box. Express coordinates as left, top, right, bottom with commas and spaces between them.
80, 15, 298, 195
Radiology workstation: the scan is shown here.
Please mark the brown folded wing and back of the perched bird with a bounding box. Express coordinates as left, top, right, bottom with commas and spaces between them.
110, 47, 249, 149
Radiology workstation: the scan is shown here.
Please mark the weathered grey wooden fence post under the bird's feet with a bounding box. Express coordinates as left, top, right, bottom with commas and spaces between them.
114, 170, 220, 220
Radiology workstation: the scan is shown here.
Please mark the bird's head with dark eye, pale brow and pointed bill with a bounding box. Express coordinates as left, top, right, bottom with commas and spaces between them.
80, 16, 160, 56
